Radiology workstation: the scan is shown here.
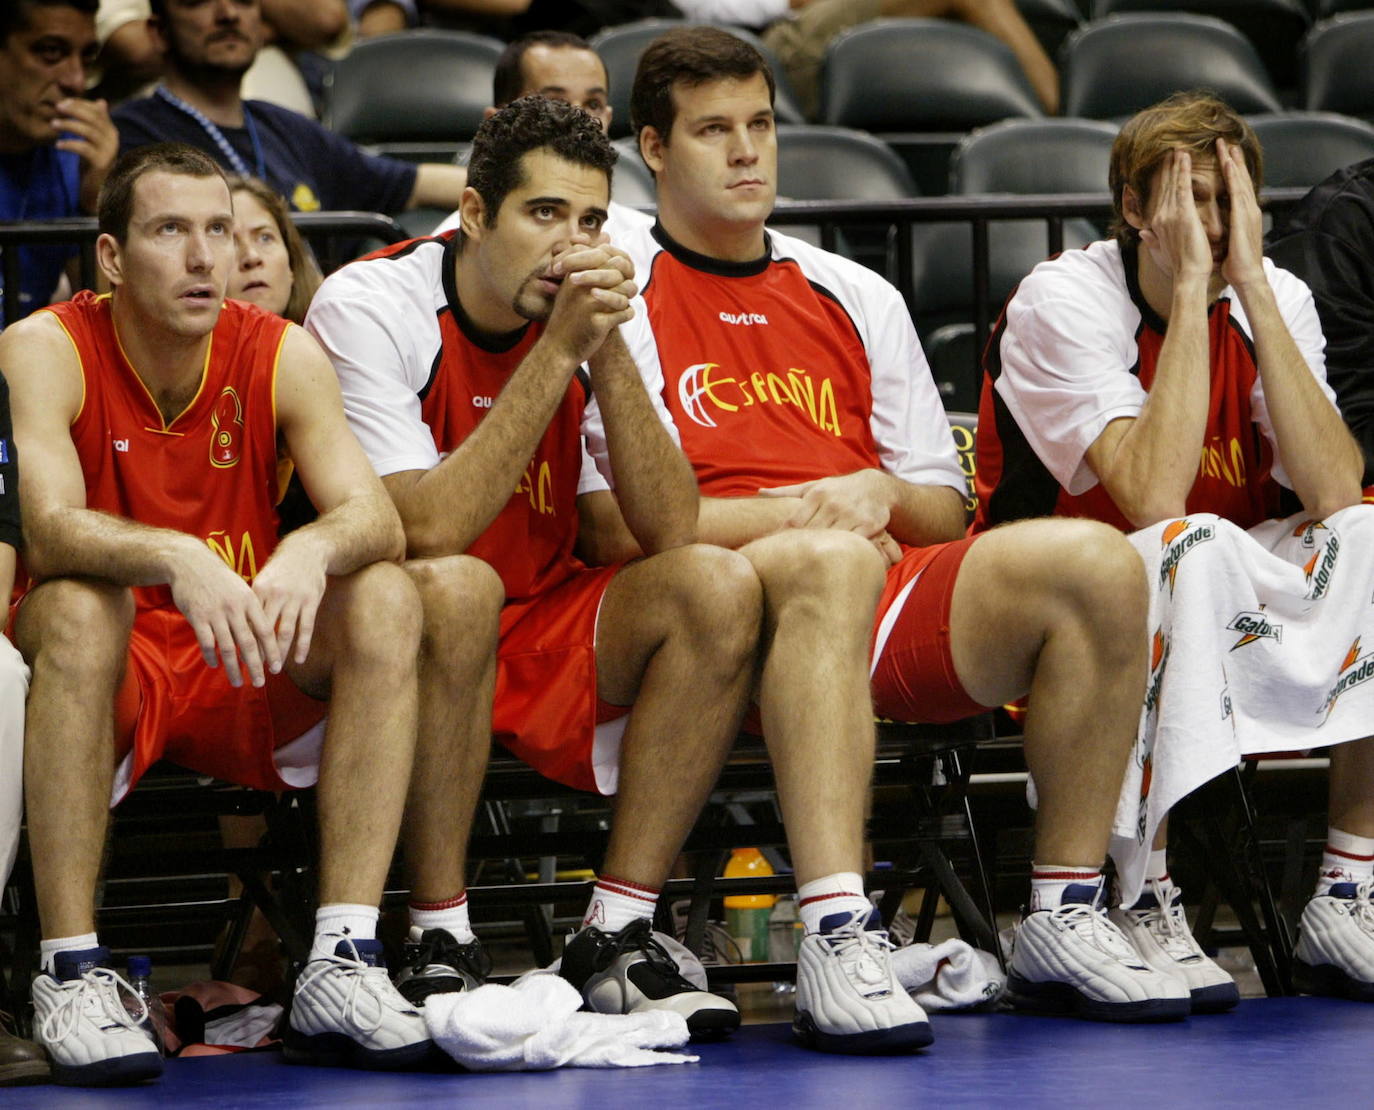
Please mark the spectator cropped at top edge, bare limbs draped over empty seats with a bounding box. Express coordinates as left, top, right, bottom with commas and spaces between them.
676, 0, 1059, 120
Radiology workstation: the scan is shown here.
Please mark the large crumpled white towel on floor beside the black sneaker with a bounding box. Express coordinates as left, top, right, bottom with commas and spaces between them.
425, 971, 698, 1072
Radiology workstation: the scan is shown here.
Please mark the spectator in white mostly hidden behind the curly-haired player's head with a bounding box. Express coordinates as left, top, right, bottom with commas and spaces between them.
434, 30, 653, 242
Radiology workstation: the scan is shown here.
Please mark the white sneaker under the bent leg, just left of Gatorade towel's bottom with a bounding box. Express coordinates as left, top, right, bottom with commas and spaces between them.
1006, 883, 1191, 1022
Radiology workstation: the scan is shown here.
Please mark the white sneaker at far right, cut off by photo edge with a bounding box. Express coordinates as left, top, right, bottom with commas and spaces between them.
1293, 882, 1374, 1001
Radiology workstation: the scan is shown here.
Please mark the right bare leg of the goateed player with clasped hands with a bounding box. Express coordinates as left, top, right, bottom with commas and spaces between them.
596, 544, 763, 887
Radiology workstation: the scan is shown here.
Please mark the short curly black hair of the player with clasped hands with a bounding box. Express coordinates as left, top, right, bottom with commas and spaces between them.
467, 96, 617, 227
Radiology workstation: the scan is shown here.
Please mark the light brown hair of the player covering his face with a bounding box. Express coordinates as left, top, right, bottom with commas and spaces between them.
1107, 89, 1264, 243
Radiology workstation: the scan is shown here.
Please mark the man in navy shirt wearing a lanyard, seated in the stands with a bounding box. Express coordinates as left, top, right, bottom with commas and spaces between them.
114, 0, 467, 212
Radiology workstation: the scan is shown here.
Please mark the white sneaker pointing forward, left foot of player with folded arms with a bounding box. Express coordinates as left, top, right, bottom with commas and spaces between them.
791, 909, 934, 1054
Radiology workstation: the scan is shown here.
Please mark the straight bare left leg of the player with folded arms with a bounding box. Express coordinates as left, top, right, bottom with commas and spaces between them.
741, 529, 883, 886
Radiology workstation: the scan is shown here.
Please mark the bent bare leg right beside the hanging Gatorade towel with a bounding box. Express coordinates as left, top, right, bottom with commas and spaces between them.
949, 519, 1147, 868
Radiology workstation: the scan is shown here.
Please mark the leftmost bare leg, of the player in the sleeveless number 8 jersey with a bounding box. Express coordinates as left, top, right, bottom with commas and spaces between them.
15, 578, 133, 937
